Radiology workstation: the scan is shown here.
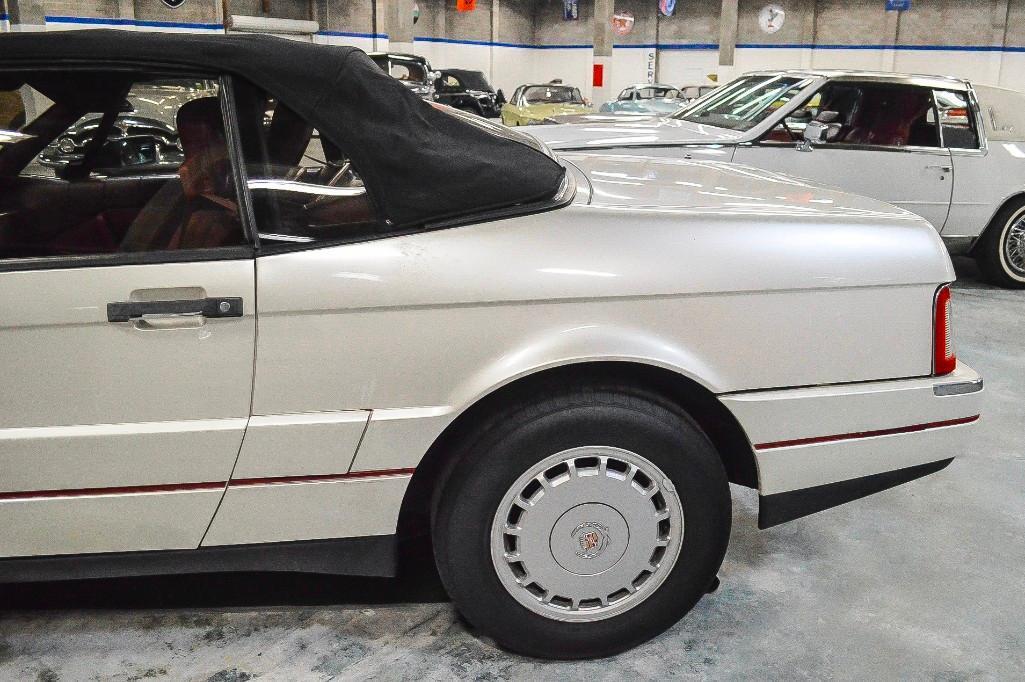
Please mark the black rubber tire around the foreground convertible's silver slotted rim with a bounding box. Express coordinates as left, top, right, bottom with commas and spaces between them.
432, 385, 731, 658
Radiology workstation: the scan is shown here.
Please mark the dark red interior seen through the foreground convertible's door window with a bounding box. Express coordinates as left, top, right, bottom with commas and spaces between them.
0, 72, 244, 258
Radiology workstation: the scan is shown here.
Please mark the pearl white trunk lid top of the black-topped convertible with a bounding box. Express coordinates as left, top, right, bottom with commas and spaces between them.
559, 153, 932, 223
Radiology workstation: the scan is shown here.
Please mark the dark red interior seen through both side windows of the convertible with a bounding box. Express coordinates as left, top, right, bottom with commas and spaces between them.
0, 72, 378, 258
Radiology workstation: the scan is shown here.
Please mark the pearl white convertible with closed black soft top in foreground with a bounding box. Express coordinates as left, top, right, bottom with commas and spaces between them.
0, 31, 982, 657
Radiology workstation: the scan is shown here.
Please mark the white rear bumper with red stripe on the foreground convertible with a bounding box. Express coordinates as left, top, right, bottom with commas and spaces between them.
721, 364, 983, 528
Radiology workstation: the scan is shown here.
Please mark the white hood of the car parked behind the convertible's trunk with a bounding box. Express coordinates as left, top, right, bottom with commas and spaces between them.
530, 118, 744, 150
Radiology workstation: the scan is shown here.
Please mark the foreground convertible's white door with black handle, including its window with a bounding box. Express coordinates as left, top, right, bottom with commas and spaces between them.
0, 68, 255, 557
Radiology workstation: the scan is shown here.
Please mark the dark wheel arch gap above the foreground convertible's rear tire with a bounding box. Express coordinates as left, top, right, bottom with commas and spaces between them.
398, 360, 759, 540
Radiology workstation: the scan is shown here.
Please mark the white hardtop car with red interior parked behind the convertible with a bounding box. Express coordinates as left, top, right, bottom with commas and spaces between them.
530, 71, 1025, 288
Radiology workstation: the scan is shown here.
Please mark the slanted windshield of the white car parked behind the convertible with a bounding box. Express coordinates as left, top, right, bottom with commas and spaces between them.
673, 75, 812, 130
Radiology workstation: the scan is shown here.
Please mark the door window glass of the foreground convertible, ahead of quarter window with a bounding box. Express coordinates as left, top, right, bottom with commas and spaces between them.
0, 71, 245, 258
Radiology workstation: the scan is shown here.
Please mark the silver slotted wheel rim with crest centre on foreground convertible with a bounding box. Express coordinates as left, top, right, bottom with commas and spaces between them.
491, 446, 684, 623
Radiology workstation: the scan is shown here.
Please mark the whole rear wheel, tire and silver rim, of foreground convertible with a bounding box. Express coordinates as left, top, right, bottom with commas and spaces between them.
433, 387, 730, 658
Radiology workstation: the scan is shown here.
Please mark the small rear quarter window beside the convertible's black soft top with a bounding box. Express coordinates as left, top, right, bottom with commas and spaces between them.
240, 88, 379, 245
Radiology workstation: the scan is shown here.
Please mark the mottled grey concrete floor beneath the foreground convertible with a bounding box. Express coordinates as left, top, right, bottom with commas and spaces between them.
0, 262, 1025, 682
